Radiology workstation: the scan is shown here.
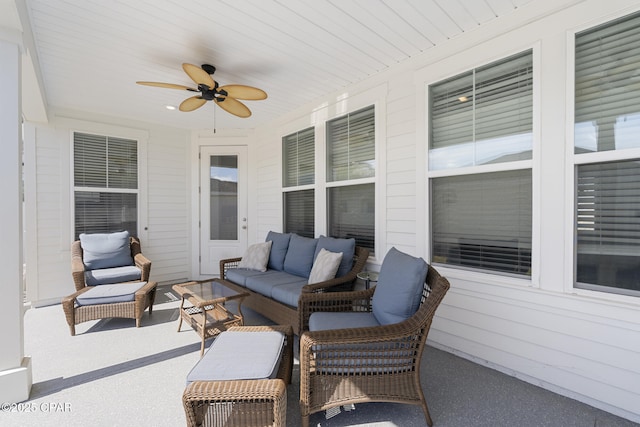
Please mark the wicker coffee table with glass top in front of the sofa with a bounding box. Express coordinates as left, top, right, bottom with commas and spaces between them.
173, 279, 249, 356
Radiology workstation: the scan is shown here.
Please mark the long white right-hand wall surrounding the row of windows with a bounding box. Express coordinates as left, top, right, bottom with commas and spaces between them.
245, 1, 640, 421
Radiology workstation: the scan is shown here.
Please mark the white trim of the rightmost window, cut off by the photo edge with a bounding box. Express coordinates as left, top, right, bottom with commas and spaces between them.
562, 8, 640, 303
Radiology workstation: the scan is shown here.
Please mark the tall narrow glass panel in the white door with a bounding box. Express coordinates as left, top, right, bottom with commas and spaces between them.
209, 155, 238, 240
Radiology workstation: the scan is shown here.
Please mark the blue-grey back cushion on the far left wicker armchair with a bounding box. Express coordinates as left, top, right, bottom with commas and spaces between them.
80, 231, 133, 270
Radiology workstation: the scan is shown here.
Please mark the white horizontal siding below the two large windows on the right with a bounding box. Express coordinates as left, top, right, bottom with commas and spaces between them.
429, 280, 640, 411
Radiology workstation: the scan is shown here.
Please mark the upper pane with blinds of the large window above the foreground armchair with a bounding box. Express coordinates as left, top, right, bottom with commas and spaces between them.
429, 50, 533, 170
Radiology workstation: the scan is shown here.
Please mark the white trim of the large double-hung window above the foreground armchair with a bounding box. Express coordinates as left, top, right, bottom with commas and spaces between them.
414, 42, 541, 288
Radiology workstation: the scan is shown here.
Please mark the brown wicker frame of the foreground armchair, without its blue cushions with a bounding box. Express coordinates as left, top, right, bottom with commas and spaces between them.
299, 263, 449, 427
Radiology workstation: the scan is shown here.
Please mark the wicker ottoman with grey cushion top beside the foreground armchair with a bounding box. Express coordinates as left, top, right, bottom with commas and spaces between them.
182, 326, 293, 427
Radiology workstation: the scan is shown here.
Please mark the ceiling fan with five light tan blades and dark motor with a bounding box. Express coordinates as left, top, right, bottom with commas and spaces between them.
136, 63, 267, 118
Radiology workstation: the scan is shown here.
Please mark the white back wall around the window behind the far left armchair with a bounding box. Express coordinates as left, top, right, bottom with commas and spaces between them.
25, 112, 191, 306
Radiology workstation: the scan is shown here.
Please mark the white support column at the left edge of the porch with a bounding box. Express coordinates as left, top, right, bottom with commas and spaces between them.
0, 40, 32, 403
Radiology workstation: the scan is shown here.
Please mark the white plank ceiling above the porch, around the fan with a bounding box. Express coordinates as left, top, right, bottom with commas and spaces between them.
26, 0, 532, 129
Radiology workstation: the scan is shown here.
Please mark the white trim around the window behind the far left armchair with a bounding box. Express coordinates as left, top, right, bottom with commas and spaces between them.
65, 118, 149, 242
